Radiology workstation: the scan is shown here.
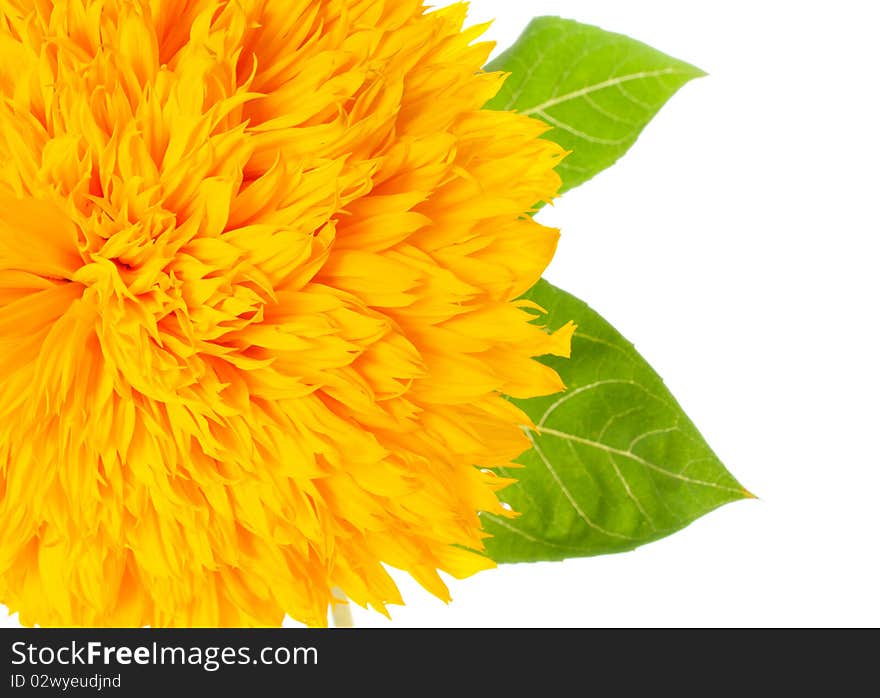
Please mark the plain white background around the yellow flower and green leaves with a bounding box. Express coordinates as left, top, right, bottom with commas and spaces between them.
0, 0, 880, 627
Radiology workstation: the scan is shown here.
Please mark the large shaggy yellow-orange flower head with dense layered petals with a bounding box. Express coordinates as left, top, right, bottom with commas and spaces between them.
0, 0, 571, 626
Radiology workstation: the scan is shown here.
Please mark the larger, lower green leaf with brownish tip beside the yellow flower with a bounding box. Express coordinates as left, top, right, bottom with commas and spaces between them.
483, 281, 751, 562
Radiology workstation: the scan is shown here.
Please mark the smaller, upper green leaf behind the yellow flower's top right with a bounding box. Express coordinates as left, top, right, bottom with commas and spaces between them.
486, 17, 705, 191
